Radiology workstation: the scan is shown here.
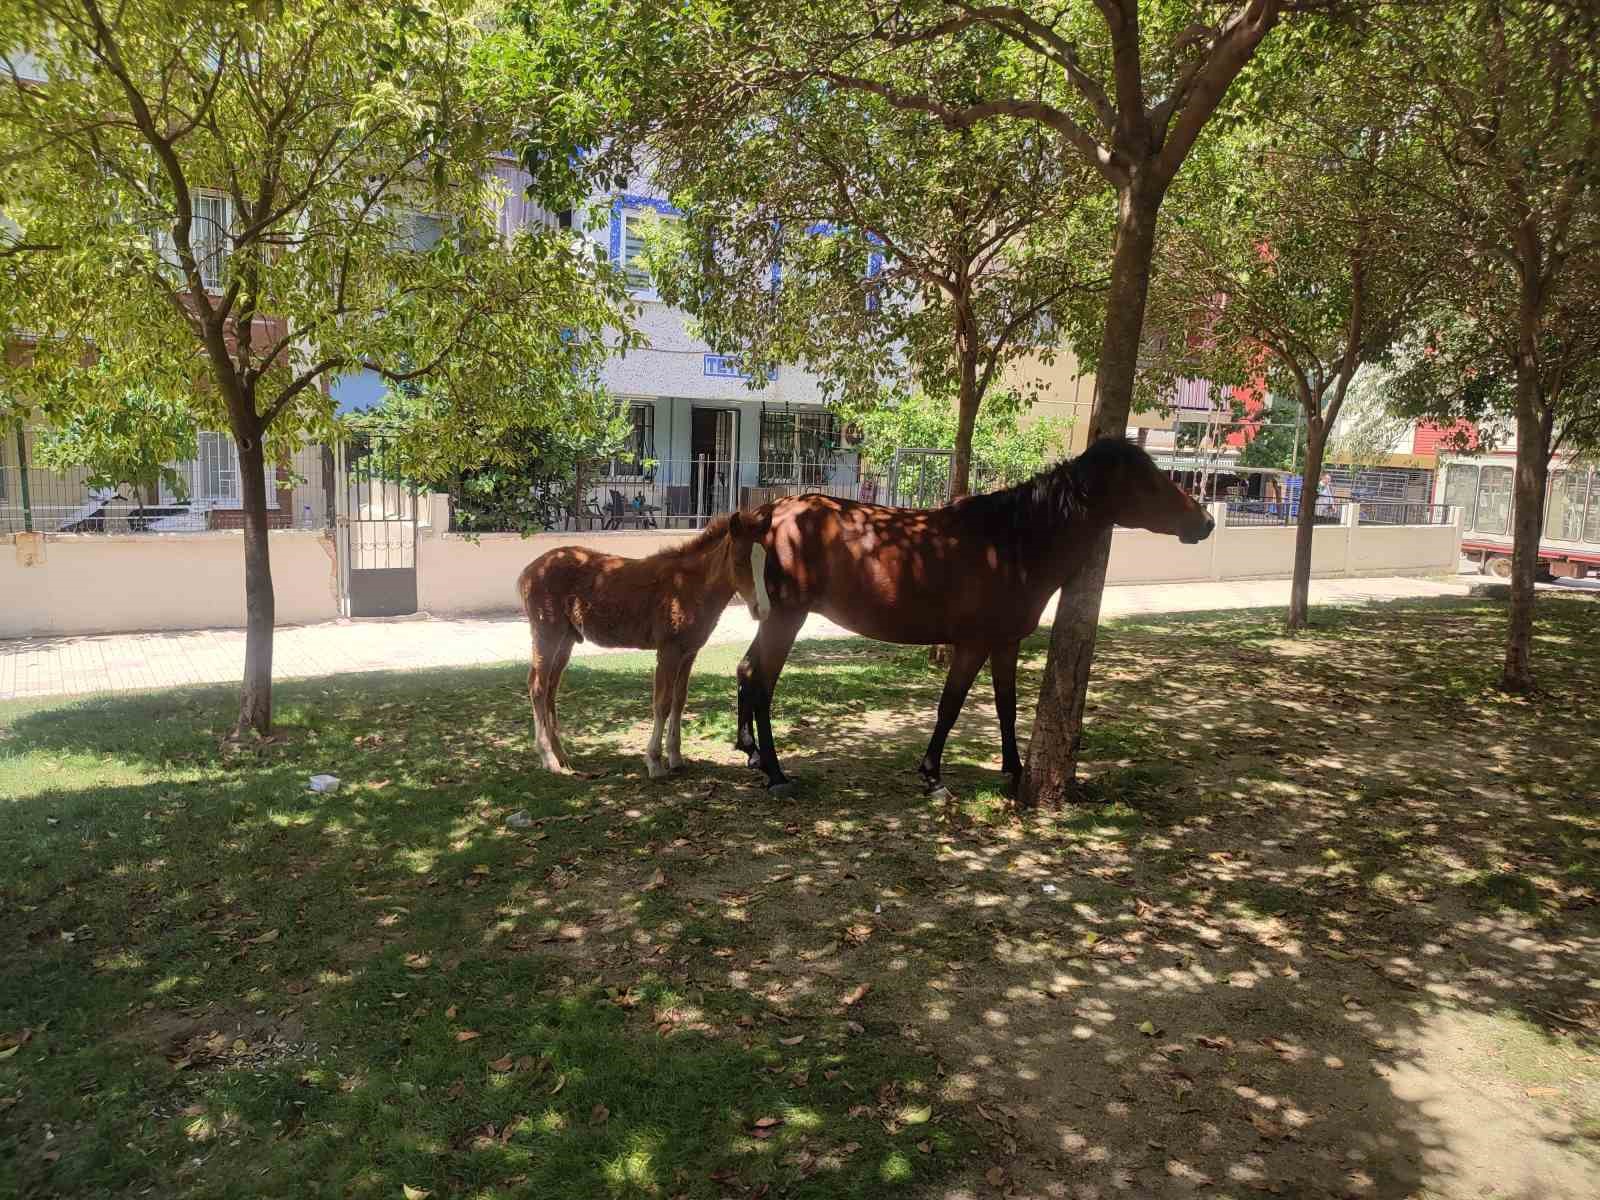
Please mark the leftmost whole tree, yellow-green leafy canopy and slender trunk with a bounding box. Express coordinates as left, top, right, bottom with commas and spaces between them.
0, 0, 626, 733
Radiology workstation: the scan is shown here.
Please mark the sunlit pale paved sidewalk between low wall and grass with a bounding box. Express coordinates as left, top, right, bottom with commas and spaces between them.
0, 578, 1467, 699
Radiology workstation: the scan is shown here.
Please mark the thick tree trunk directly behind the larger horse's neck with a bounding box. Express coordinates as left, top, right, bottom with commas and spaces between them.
1018, 186, 1162, 808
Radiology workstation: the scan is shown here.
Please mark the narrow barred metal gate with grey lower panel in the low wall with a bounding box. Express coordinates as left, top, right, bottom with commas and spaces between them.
334, 434, 418, 616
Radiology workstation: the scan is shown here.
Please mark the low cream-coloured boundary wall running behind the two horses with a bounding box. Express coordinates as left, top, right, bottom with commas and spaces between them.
0, 496, 1461, 637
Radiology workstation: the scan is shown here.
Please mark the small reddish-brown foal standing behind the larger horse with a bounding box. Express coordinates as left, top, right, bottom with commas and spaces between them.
517, 512, 768, 779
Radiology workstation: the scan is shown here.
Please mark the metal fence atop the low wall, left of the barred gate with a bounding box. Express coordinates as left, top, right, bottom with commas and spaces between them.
0, 434, 333, 534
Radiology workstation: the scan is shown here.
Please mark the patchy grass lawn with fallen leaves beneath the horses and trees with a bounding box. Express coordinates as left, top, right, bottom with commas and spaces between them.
0, 597, 1600, 1200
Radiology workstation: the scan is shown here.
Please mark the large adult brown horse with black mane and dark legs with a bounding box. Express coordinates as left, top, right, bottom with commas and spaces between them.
734, 438, 1213, 797
